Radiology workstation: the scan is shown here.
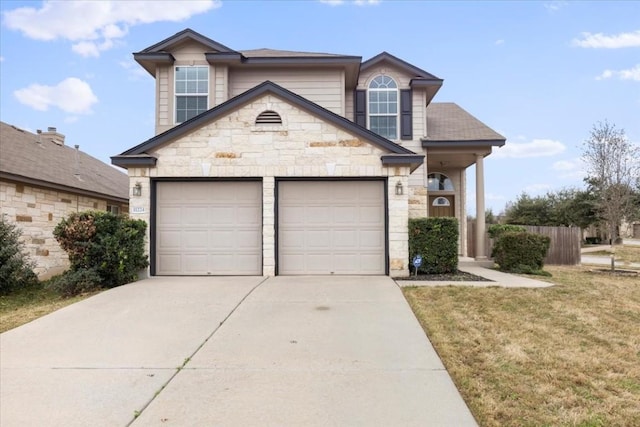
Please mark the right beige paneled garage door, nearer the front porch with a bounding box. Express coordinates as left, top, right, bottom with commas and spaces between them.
278, 181, 386, 274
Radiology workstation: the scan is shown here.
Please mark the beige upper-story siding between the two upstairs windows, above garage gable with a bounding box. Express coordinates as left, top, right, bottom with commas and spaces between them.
229, 69, 344, 115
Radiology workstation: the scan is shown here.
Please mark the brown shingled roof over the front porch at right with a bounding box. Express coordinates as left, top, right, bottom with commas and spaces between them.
421, 102, 506, 147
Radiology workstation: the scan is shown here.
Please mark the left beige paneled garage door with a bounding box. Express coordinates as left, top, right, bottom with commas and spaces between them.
155, 181, 262, 276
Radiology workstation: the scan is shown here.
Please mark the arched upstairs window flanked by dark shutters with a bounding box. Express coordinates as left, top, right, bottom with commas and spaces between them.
369, 76, 398, 139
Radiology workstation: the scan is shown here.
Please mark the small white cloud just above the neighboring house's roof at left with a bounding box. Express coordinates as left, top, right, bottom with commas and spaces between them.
13, 77, 98, 114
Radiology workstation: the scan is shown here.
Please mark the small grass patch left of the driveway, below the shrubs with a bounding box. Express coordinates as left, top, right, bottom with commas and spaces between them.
0, 283, 98, 333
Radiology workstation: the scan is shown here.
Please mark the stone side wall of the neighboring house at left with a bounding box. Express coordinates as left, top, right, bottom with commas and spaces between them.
0, 181, 127, 279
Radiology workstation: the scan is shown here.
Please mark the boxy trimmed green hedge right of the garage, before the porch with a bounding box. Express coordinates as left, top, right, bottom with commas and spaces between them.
409, 217, 458, 274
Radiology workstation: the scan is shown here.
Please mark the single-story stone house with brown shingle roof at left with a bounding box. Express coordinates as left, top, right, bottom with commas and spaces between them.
0, 122, 129, 279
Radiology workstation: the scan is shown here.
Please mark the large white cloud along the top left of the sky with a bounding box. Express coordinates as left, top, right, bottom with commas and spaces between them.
3, 0, 221, 57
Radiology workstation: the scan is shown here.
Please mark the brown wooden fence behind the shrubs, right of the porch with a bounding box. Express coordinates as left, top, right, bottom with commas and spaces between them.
467, 221, 582, 265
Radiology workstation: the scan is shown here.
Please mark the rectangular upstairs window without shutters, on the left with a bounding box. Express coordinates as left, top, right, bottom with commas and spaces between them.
175, 67, 209, 123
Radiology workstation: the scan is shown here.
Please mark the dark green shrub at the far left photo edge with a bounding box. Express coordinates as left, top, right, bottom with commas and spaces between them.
0, 215, 38, 295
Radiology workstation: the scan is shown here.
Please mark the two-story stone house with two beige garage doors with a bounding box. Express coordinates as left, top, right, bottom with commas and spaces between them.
112, 29, 505, 276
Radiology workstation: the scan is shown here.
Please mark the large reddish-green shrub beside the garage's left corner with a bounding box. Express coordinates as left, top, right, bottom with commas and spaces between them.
53, 211, 148, 288
